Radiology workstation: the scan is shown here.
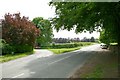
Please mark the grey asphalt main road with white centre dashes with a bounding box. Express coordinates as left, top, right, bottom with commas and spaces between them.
0, 44, 100, 78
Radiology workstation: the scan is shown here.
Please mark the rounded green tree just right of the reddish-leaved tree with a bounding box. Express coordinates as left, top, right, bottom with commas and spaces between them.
32, 17, 53, 46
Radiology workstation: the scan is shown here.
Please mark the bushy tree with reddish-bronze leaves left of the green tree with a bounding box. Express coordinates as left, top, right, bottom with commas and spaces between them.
2, 13, 40, 47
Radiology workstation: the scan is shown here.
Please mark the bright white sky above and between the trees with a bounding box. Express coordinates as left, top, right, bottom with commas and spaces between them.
0, 0, 100, 39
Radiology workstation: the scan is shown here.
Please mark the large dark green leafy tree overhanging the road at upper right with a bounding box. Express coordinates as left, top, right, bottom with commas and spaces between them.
50, 2, 120, 44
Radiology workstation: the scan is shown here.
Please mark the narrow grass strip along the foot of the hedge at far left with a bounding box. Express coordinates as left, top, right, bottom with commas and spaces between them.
0, 51, 34, 63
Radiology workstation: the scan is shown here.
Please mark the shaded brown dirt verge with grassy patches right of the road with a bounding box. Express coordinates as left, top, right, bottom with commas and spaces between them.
70, 50, 119, 78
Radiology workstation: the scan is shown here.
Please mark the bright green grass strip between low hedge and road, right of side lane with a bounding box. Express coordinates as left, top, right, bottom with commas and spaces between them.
48, 47, 80, 54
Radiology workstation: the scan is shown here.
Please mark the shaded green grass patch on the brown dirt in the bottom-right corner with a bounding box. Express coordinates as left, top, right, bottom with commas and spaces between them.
80, 63, 118, 78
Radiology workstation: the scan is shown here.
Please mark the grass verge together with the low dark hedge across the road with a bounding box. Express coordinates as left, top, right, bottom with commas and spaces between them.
48, 42, 93, 54
